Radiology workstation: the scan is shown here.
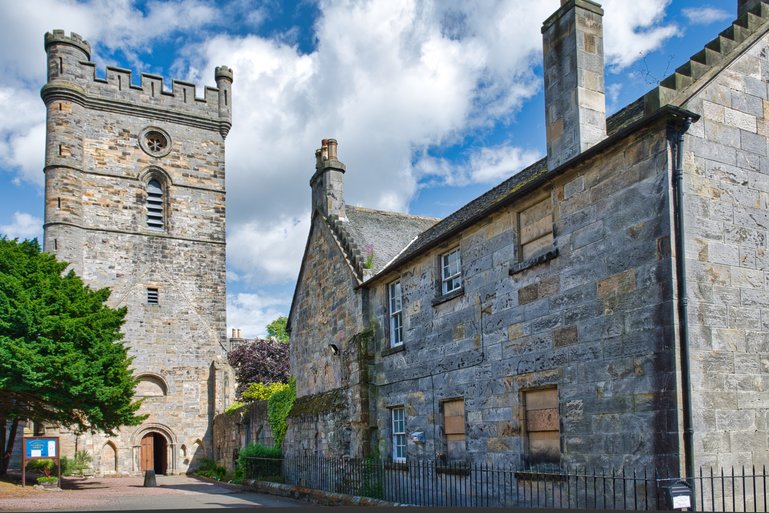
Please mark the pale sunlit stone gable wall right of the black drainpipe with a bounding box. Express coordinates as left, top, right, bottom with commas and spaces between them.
684, 29, 769, 468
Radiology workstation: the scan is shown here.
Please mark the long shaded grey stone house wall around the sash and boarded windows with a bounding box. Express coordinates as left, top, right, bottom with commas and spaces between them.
370, 121, 679, 470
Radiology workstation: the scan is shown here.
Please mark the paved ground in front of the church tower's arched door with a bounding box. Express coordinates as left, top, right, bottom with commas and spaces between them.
0, 476, 309, 511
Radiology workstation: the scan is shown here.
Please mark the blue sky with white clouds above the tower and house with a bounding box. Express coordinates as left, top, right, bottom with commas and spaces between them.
0, 0, 737, 336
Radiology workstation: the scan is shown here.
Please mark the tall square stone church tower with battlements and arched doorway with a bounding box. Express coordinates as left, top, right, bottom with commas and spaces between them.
41, 30, 234, 474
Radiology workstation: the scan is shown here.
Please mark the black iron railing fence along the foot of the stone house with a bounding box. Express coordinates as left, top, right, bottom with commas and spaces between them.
245, 455, 769, 512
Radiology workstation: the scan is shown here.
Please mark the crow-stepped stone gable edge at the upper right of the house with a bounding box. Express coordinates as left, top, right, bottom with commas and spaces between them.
644, 0, 769, 113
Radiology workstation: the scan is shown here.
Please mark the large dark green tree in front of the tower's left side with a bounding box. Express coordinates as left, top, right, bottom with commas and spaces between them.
0, 237, 145, 475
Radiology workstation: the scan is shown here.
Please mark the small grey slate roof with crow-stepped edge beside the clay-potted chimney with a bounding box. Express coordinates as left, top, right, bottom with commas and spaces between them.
327, 205, 439, 280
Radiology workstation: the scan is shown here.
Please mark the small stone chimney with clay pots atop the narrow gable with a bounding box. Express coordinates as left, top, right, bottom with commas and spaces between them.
310, 139, 346, 219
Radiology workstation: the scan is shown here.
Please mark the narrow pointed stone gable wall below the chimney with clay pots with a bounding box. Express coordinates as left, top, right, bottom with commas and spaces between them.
290, 218, 368, 456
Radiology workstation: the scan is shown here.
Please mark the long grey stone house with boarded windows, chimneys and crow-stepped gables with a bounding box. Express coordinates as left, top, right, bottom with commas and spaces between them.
284, 0, 769, 475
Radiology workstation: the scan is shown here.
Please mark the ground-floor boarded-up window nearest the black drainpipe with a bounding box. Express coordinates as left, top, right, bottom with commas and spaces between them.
523, 388, 561, 464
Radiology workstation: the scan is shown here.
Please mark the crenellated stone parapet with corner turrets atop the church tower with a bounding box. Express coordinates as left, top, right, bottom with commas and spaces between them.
41, 30, 233, 137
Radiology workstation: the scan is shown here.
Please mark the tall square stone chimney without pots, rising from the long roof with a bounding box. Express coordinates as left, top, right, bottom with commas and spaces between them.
542, 0, 606, 169
